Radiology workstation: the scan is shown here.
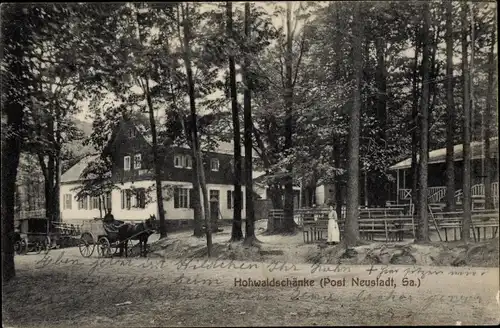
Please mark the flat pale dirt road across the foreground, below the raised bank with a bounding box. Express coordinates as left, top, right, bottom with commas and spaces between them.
2, 248, 500, 327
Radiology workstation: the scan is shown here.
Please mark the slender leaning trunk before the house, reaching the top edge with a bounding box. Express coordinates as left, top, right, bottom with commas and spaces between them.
181, 3, 212, 257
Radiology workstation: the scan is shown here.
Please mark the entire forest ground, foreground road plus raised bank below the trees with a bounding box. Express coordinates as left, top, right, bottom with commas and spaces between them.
2, 223, 500, 327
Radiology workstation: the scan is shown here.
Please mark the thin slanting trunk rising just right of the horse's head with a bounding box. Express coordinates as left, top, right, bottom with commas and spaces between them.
144, 76, 167, 238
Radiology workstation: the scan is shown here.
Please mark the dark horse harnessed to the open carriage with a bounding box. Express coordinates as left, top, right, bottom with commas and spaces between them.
118, 215, 158, 257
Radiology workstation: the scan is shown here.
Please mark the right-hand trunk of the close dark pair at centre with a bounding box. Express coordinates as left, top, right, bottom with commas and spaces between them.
243, 2, 255, 243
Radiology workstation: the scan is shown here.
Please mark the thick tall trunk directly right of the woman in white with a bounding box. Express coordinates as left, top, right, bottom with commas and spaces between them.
344, 3, 363, 248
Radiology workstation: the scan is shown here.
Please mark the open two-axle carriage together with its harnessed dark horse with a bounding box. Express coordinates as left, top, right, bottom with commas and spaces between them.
79, 215, 157, 257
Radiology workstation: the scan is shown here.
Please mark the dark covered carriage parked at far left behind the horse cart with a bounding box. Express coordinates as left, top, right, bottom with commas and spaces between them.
14, 217, 51, 255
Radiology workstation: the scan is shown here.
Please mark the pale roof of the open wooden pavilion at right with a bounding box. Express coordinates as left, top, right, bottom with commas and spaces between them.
389, 137, 498, 170
